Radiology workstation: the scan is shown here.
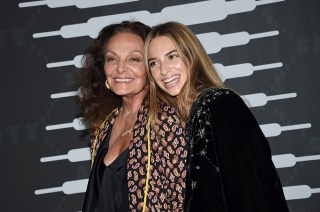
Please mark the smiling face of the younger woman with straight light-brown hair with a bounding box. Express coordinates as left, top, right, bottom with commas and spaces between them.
147, 36, 188, 96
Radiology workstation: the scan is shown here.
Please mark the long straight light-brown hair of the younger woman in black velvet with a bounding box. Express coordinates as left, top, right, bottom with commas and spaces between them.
144, 22, 224, 125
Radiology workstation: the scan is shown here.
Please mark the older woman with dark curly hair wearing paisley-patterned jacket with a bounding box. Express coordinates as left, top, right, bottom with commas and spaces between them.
80, 21, 187, 212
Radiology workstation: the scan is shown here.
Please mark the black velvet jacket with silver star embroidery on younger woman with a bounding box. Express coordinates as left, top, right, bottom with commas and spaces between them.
185, 88, 288, 212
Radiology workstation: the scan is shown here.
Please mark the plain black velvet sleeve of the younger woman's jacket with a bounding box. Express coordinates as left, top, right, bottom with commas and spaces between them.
209, 91, 287, 212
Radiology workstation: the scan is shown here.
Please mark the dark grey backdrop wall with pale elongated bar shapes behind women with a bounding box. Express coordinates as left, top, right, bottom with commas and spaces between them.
0, 0, 320, 212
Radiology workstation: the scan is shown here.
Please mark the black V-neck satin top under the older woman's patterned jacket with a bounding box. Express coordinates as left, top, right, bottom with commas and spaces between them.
83, 130, 129, 212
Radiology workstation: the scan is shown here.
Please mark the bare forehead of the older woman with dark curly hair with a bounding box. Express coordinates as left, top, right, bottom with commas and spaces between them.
106, 32, 144, 51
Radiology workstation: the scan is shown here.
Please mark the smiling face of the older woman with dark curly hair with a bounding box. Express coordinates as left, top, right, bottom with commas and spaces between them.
104, 32, 147, 97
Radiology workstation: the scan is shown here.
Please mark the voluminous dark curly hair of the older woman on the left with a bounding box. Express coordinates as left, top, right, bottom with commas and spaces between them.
79, 21, 150, 133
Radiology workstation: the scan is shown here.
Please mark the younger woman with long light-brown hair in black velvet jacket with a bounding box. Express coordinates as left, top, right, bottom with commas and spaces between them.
145, 22, 288, 212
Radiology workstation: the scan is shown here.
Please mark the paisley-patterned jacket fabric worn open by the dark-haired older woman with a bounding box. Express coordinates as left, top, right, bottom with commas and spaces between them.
92, 100, 187, 211
